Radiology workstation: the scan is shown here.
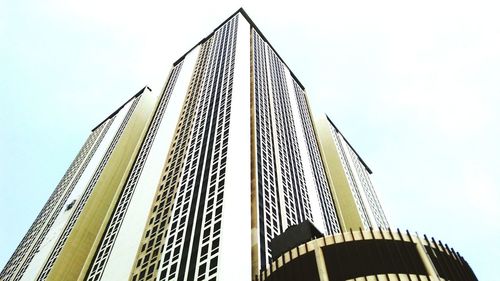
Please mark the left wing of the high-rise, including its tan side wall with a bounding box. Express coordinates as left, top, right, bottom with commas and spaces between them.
0, 88, 156, 281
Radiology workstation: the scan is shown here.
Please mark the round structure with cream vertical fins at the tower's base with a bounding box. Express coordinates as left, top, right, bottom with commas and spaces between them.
253, 229, 477, 281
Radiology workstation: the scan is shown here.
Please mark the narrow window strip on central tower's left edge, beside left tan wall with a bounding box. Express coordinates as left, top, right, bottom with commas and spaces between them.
87, 63, 182, 281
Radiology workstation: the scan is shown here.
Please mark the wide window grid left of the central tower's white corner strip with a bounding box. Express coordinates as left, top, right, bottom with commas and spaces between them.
132, 17, 238, 280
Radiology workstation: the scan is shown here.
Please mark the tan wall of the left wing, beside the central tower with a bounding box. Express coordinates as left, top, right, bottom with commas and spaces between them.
47, 93, 155, 281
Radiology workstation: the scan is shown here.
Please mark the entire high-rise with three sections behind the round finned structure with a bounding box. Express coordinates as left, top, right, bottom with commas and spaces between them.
0, 9, 476, 281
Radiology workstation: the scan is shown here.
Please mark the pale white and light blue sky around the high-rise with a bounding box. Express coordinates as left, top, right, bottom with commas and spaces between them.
0, 0, 500, 281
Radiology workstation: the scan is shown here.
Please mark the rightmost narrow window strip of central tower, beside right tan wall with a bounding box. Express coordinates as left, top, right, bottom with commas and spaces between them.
293, 81, 341, 234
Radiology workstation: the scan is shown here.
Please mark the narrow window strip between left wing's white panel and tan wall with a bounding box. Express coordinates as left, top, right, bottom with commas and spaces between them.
37, 97, 140, 281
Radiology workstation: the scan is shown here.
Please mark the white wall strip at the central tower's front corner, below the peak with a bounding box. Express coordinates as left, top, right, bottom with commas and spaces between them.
217, 15, 252, 281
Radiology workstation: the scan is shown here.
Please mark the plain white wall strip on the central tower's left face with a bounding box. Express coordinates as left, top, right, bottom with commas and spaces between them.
101, 48, 198, 280
